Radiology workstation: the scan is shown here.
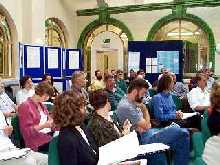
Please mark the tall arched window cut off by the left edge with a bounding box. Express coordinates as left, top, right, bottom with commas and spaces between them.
0, 15, 13, 78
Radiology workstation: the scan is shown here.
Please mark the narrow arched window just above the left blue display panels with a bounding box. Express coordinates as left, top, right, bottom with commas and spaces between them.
45, 18, 67, 48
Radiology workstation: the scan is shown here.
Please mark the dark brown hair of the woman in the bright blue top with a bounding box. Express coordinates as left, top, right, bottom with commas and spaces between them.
157, 75, 173, 93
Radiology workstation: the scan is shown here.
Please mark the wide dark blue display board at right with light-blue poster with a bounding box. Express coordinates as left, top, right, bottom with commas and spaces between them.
128, 41, 184, 83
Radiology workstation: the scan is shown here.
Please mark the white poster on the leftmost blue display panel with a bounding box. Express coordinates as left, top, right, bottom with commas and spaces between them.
27, 46, 40, 68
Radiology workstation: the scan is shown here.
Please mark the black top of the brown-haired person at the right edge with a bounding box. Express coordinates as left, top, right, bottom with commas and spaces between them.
207, 110, 220, 135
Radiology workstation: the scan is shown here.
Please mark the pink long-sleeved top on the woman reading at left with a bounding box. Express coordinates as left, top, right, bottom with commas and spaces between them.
18, 97, 52, 151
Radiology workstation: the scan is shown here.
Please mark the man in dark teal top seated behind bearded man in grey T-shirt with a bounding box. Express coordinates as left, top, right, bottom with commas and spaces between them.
105, 74, 125, 111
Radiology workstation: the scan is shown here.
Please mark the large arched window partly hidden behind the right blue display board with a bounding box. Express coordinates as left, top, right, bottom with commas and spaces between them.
153, 19, 211, 73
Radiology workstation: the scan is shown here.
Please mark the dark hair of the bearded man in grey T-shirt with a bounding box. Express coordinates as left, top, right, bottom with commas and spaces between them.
128, 79, 149, 93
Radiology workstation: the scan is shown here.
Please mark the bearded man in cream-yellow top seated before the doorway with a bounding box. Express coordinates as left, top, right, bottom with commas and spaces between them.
89, 70, 105, 92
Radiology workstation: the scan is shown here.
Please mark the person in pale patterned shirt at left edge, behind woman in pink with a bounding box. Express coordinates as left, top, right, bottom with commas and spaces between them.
0, 78, 17, 125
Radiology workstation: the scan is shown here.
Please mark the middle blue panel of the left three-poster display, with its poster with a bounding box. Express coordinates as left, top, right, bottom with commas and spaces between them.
45, 47, 63, 78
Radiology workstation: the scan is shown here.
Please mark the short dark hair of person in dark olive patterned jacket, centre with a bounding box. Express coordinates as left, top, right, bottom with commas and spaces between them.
89, 89, 108, 110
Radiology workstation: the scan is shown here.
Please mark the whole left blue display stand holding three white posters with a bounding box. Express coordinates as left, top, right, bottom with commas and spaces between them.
19, 43, 83, 90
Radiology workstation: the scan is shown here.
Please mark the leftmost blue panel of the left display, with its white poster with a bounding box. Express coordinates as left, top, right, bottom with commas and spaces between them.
23, 45, 44, 78
